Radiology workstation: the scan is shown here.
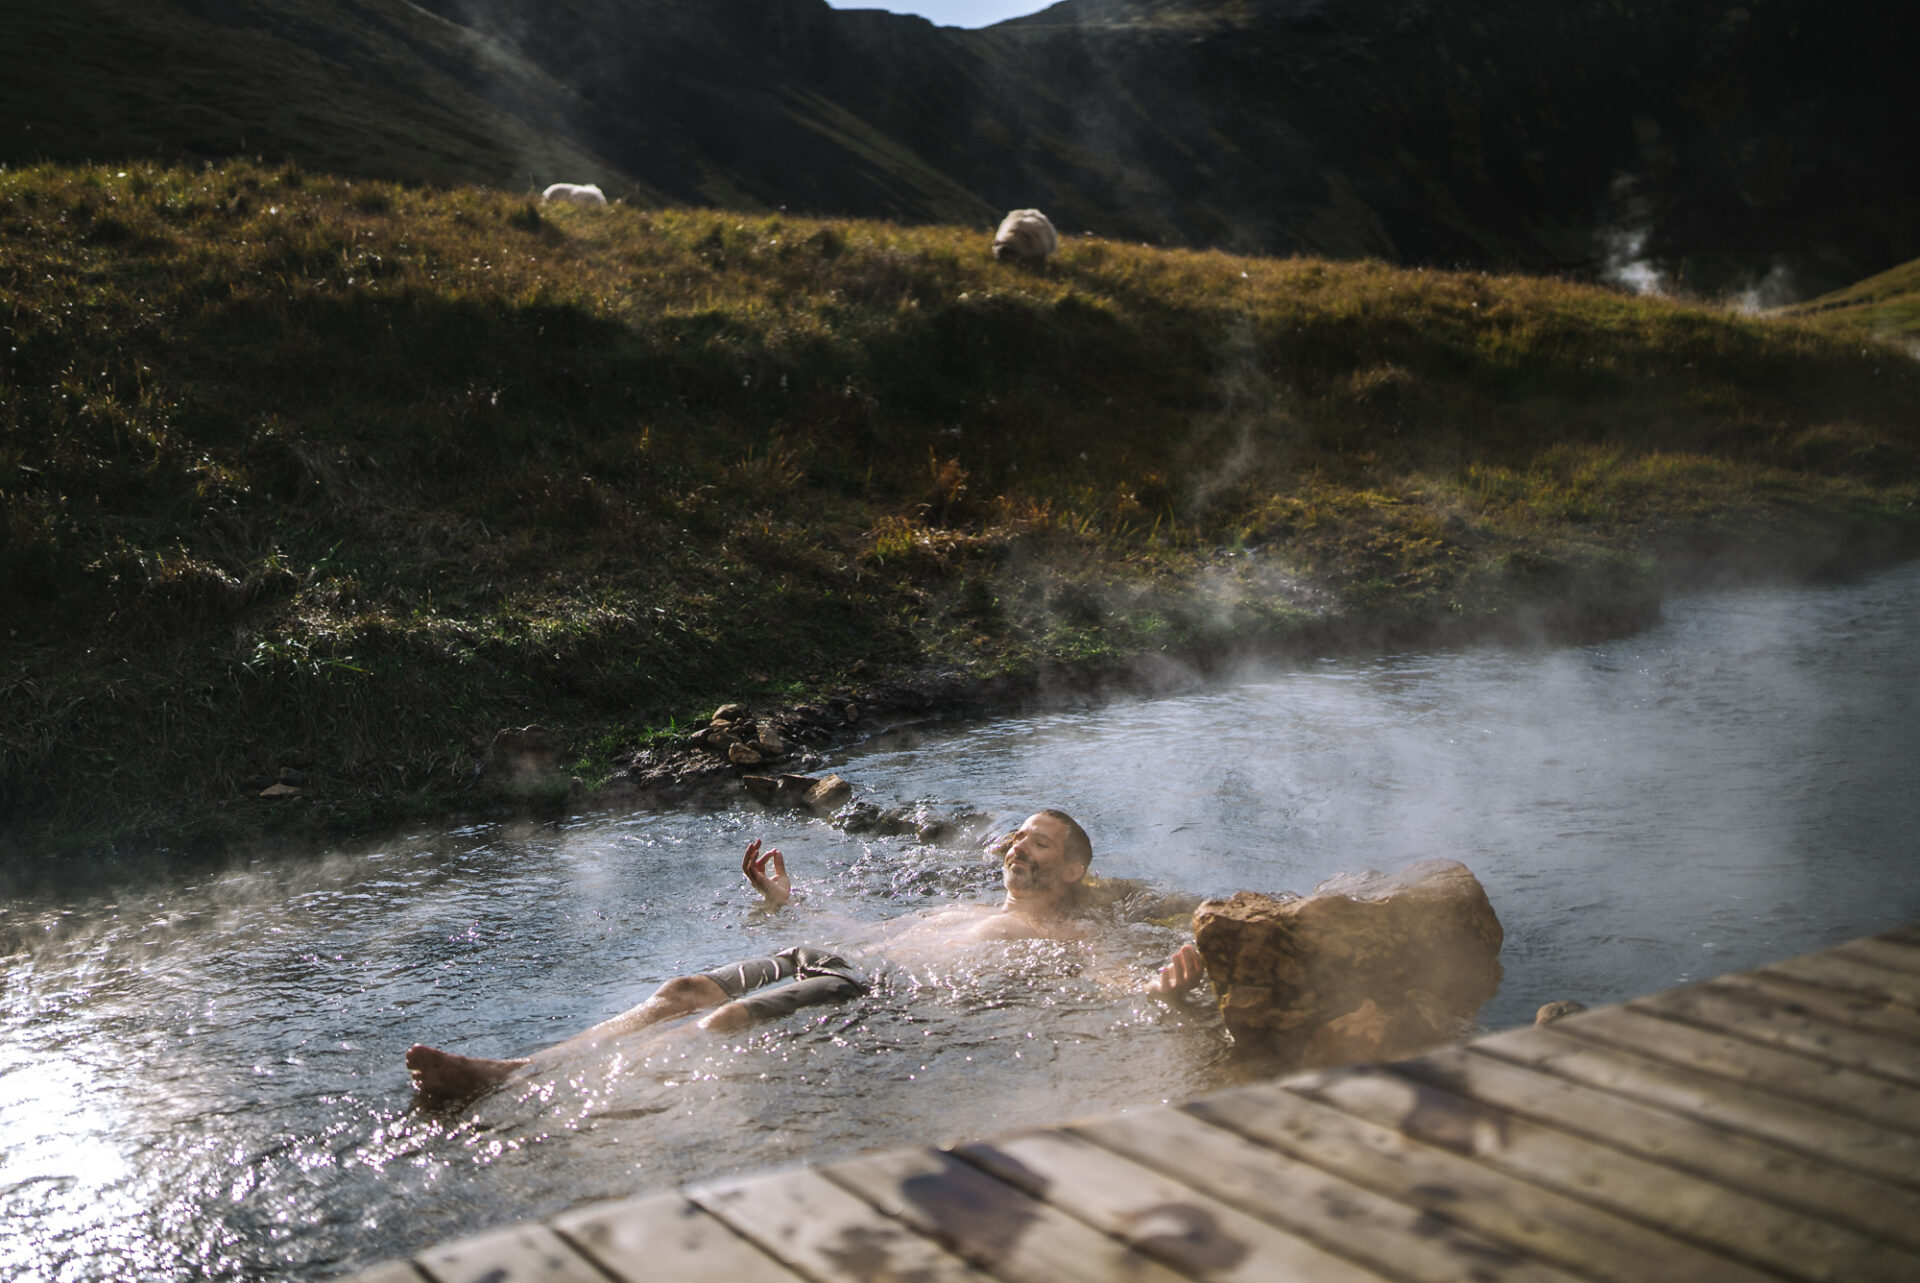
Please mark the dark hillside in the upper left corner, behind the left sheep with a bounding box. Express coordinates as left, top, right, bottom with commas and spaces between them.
0, 0, 620, 186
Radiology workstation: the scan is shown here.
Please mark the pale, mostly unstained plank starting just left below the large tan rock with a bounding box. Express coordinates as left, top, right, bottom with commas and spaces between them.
1068, 1108, 1574, 1283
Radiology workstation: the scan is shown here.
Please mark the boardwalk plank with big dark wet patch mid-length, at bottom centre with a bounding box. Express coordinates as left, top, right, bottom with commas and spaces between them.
820, 1149, 1181, 1283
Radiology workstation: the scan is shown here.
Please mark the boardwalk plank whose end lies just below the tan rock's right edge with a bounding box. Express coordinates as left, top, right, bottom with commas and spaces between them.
1384, 1049, 1920, 1244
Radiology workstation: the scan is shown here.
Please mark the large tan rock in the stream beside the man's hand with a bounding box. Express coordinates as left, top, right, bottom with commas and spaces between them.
1194, 860, 1503, 1066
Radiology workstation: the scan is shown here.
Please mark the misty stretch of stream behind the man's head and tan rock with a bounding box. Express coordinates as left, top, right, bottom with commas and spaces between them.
841, 567, 1920, 1026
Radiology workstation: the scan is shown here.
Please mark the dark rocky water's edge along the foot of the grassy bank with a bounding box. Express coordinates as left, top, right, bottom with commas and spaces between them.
22, 538, 1916, 876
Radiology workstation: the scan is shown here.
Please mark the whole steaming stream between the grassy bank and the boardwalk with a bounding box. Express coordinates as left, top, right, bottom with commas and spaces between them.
0, 565, 1920, 1283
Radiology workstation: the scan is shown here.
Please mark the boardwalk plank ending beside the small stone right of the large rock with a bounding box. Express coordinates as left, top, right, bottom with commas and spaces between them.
1471, 1022, 1920, 1190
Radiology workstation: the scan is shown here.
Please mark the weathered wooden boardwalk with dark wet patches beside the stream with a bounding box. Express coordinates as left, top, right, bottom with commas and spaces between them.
345, 926, 1920, 1283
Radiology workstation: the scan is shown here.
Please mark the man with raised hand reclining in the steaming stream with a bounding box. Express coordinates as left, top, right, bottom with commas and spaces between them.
407, 811, 1202, 1101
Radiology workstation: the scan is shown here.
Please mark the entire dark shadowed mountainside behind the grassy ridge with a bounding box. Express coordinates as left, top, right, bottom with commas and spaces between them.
0, 0, 1920, 294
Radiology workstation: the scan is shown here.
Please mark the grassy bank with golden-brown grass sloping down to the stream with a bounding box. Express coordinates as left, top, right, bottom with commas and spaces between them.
0, 163, 1920, 849
